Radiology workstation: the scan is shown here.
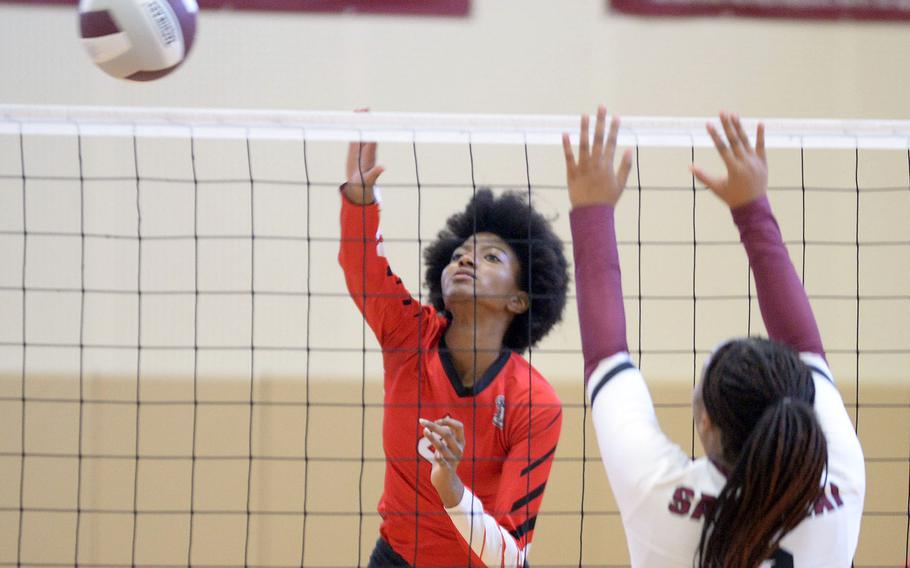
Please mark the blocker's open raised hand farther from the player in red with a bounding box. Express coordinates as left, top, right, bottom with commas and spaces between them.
689, 112, 768, 209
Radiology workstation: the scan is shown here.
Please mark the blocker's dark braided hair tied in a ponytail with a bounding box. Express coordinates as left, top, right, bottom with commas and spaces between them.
696, 339, 828, 568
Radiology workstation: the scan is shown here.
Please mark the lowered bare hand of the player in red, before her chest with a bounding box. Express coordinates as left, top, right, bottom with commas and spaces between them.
420, 417, 465, 507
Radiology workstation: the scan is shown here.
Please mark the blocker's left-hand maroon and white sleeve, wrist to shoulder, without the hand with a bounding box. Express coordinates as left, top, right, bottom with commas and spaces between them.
571, 205, 689, 515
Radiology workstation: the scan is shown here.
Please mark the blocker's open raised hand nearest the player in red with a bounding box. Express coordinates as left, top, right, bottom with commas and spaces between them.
562, 105, 632, 208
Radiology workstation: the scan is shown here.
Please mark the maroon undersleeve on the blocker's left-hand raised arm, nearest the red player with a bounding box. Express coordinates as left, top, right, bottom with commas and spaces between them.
569, 204, 629, 384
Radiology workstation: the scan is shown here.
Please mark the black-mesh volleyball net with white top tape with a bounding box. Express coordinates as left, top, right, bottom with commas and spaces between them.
0, 106, 910, 567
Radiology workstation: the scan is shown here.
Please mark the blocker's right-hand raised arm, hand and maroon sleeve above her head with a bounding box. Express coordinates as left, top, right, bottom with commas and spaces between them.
691, 113, 824, 356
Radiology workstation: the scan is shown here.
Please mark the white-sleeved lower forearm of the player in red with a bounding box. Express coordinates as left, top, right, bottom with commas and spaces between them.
446, 488, 525, 566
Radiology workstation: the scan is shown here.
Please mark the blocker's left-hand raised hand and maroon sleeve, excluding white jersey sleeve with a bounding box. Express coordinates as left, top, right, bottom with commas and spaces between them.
562, 106, 632, 384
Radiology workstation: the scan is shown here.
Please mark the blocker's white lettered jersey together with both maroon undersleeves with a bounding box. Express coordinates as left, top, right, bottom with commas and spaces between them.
571, 197, 865, 568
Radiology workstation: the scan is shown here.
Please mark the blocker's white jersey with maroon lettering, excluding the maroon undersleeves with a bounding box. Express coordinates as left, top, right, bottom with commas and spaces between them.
587, 353, 866, 568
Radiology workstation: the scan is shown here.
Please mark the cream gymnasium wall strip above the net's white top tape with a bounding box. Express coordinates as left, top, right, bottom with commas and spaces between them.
0, 0, 910, 118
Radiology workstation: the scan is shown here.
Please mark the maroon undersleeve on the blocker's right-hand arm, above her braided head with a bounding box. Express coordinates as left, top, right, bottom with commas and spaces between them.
732, 196, 825, 356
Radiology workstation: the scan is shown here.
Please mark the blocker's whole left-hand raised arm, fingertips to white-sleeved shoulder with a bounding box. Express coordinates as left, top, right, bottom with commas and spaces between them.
563, 107, 689, 516
